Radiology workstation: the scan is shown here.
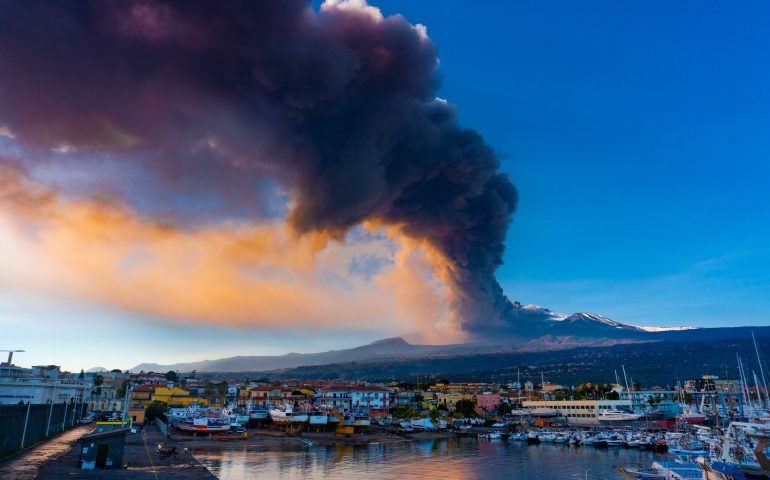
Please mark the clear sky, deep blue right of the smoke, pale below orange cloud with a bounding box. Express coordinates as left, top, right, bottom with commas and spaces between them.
0, 0, 770, 369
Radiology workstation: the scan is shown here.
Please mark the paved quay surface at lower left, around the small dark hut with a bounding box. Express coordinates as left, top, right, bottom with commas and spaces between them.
0, 426, 216, 480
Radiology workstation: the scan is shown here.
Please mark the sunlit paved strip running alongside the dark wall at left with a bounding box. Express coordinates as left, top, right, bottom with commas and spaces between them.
0, 425, 94, 480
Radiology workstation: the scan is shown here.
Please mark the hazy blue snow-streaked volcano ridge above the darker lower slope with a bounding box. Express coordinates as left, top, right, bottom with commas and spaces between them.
131, 303, 770, 372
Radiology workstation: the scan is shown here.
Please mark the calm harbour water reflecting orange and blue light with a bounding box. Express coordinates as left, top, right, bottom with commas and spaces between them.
193, 438, 656, 480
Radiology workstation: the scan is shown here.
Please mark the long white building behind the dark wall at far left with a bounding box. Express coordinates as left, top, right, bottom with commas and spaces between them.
0, 362, 91, 405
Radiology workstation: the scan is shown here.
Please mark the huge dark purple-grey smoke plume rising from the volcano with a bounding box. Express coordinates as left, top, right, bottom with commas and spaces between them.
0, 0, 517, 331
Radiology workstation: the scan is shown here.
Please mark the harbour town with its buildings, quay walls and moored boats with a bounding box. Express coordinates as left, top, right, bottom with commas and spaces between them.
0, 346, 770, 479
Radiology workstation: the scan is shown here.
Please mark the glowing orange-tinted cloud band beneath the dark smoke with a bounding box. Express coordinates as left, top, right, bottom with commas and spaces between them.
0, 169, 458, 342
